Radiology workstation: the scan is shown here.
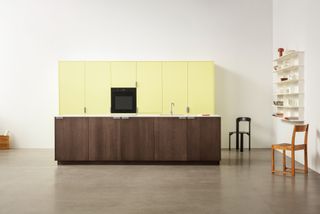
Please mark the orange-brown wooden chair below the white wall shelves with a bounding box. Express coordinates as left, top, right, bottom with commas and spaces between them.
272, 124, 309, 176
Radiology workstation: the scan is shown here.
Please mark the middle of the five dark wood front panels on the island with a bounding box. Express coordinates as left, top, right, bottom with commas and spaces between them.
120, 117, 154, 161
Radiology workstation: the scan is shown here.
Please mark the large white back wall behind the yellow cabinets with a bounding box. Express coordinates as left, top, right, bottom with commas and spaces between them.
0, 0, 272, 148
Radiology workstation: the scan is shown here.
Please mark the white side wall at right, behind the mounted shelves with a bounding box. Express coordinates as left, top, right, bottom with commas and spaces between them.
273, 0, 320, 172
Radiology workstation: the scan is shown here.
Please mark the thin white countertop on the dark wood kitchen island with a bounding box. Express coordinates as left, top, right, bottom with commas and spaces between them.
55, 114, 221, 118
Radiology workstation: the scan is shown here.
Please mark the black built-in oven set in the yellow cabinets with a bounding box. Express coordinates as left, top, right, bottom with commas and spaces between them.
111, 88, 137, 113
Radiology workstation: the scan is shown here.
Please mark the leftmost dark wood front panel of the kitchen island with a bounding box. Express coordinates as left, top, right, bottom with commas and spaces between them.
55, 117, 89, 161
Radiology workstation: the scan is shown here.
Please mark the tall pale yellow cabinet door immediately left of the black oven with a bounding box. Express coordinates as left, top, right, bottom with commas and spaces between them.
85, 61, 111, 115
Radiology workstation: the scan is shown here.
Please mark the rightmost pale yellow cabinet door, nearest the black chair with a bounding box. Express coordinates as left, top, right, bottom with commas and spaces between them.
188, 61, 215, 114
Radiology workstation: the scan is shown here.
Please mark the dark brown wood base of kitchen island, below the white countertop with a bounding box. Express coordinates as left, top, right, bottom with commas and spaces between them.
55, 117, 221, 163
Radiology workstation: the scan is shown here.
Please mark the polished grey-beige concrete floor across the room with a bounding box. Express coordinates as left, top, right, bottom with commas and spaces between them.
0, 149, 320, 214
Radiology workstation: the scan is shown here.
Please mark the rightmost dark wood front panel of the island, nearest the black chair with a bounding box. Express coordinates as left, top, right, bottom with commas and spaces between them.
187, 117, 221, 161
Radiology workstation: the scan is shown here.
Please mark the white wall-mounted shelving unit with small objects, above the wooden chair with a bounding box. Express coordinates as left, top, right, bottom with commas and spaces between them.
273, 51, 304, 123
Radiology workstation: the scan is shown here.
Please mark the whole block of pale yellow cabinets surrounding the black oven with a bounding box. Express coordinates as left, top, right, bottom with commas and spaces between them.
59, 61, 216, 115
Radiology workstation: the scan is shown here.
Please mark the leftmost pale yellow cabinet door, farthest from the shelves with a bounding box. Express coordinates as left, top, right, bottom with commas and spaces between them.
59, 61, 85, 115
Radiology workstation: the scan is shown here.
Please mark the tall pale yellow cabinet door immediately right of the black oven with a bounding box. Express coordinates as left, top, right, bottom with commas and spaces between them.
137, 62, 162, 114
